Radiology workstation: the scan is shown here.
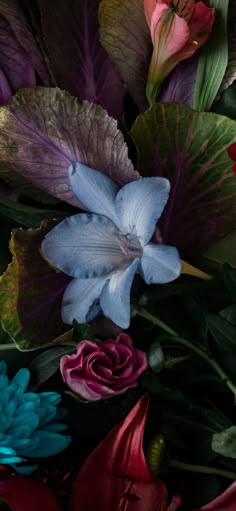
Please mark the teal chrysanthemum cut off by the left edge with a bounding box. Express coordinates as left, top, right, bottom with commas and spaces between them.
0, 361, 71, 473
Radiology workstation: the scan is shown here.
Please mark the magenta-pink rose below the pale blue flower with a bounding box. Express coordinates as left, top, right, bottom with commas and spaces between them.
60, 333, 148, 401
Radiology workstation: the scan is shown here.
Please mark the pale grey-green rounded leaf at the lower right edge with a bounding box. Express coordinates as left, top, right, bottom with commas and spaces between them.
211, 426, 236, 459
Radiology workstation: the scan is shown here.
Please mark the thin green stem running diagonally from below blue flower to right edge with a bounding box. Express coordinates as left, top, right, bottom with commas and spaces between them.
137, 308, 236, 396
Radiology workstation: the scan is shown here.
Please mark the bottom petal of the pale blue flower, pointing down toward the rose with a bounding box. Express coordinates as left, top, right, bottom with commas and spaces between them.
100, 259, 140, 328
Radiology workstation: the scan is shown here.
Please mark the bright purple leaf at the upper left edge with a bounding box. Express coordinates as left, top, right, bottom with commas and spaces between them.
0, 17, 36, 105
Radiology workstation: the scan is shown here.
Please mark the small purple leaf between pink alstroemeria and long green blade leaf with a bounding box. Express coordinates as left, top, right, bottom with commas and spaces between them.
159, 55, 198, 107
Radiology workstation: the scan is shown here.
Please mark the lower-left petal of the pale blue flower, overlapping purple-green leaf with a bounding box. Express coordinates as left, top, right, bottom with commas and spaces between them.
61, 276, 110, 325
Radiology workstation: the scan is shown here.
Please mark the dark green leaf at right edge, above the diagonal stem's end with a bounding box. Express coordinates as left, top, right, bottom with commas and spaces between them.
207, 314, 236, 351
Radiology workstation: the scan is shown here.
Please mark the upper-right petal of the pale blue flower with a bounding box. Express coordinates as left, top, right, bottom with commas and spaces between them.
115, 177, 170, 246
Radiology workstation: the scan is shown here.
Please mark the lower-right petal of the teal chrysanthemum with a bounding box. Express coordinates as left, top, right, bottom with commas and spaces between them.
27, 430, 71, 458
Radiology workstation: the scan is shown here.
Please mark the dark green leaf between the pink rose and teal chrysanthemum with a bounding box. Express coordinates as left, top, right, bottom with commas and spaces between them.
28, 344, 76, 387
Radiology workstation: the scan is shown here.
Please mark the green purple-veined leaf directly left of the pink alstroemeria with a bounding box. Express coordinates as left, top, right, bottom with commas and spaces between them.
99, 0, 152, 110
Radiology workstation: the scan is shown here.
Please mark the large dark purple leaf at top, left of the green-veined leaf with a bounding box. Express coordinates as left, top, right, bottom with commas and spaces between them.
38, 0, 125, 118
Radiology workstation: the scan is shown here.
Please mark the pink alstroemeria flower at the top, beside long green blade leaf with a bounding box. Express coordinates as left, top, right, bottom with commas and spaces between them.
144, 0, 214, 104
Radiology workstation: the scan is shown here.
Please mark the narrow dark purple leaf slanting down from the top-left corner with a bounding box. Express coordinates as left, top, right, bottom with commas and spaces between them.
0, 0, 50, 85
